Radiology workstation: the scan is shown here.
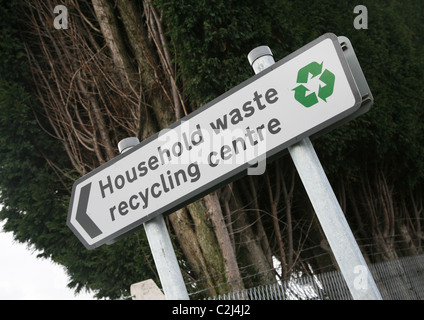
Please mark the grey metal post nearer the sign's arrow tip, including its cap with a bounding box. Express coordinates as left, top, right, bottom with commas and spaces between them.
118, 137, 189, 300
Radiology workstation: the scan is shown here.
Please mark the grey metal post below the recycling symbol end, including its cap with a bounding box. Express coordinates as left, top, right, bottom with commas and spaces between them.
248, 46, 382, 300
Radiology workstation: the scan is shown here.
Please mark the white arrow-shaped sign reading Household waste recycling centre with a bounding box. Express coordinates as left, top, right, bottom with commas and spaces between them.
67, 34, 362, 249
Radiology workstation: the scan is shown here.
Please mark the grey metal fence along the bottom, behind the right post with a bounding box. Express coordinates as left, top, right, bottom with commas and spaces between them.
210, 254, 424, 300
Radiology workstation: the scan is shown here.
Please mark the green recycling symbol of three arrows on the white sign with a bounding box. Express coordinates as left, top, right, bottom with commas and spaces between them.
293, 62, 336, 108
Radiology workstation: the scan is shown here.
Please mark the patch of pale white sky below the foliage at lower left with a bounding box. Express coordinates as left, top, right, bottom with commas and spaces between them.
0, 222, 94, 300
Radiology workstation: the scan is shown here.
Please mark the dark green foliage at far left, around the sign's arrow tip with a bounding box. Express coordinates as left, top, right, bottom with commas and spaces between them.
0, 0, 157, 298
